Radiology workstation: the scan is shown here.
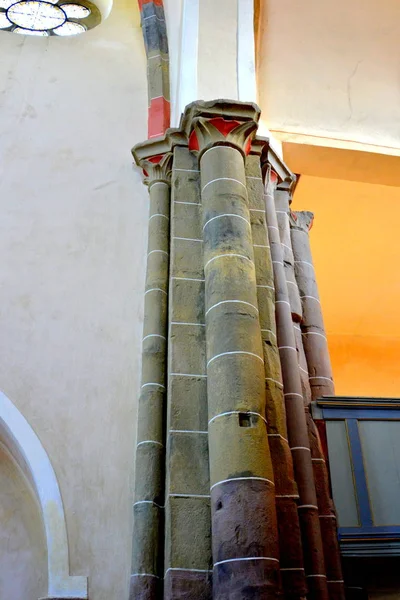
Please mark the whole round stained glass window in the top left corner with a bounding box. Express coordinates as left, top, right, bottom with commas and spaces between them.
0, 0, 100, 37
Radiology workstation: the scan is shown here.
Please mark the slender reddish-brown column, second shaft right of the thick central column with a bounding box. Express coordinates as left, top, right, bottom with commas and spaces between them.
265, 171, 329, 600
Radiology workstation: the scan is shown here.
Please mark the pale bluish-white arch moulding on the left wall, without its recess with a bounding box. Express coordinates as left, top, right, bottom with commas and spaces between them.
0, 392, 88, 600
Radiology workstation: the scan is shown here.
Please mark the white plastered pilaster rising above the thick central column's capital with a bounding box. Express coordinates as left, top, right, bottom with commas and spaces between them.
164, 0, 269, 126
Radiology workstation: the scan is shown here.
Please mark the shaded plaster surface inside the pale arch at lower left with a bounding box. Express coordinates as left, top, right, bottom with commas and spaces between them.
0, 444, 47, 600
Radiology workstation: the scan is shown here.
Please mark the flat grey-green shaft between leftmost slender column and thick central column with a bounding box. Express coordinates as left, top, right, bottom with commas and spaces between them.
164, 147, 212, 600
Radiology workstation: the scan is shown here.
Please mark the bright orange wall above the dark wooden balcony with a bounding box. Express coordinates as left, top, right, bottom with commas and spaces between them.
292, 175, 400, 397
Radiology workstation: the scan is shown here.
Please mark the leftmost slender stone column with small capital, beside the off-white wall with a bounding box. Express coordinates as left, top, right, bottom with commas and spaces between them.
130, 153, 172, 600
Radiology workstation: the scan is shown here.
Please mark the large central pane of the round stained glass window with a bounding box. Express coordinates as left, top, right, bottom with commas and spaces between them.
7, 0, 65, 31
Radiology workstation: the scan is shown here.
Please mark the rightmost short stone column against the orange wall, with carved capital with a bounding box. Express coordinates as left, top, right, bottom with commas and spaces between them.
291, 212, 335, 400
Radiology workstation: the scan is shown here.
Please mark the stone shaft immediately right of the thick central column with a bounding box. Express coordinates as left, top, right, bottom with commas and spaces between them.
246, 146, 307, 600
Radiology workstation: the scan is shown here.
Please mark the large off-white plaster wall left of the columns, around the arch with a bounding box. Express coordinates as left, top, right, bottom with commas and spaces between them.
0, 0, 148, 600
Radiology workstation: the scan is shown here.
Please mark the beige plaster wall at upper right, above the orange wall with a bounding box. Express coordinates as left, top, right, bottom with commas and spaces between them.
258, 0, 400, 153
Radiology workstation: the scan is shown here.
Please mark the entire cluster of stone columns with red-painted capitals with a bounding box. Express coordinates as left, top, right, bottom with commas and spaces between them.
130, 100, 344, 600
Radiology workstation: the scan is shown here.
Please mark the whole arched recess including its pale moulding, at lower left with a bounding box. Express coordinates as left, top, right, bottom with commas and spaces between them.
0, 392, 87, 600
